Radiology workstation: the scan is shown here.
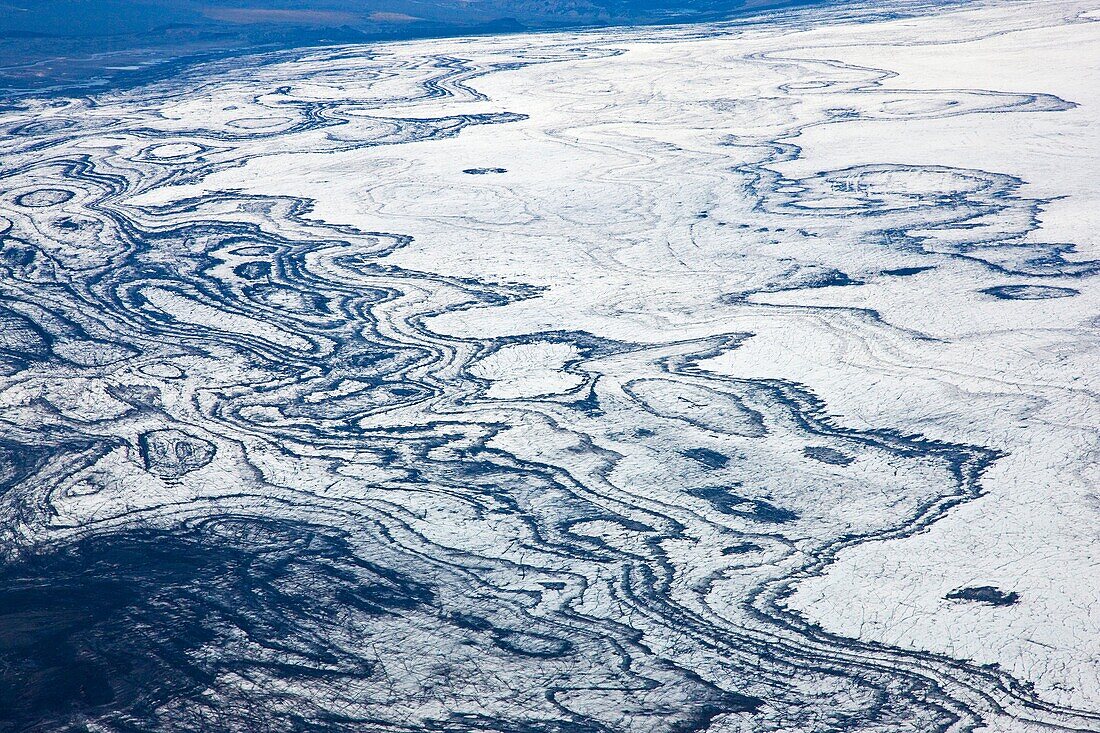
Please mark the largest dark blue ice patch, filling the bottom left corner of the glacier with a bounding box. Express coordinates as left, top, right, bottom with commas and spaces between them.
0, 518, 433, 731
